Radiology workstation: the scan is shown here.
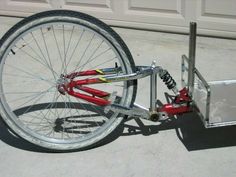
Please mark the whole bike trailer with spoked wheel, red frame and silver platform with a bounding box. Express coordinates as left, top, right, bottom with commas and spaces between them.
4, 10, 236, 151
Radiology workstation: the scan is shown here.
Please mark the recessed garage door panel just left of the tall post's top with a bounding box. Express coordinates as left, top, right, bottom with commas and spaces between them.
123, 0, 186, 26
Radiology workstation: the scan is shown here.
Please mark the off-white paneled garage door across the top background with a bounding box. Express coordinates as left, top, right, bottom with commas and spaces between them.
0, 0, 236, 38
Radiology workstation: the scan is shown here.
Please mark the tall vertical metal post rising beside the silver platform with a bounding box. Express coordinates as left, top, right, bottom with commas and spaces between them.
188, 22, 197, 96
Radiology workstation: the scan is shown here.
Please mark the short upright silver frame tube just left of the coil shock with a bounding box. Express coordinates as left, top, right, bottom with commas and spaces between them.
150, 61, 157, 112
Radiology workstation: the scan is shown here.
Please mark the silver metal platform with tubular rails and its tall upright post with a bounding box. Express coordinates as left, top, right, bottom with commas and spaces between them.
181, 23, 236, 128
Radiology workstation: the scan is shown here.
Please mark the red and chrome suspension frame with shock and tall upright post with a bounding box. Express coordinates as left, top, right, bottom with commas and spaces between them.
57, 23, 196, 121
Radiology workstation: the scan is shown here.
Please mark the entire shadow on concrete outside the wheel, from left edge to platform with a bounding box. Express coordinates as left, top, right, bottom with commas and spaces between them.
0, 99, 236, 152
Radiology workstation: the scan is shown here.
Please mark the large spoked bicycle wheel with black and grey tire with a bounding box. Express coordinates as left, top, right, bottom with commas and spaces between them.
0, 10, 137, 151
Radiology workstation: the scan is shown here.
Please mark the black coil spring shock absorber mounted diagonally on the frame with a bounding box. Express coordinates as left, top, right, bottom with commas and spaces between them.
159, 69, 178, 94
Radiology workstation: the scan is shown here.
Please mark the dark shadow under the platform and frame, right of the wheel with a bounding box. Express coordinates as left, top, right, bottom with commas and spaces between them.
122, 110, 236, 151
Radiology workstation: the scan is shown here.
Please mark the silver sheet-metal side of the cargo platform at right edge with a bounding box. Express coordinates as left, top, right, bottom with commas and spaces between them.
193, 78, 236, 128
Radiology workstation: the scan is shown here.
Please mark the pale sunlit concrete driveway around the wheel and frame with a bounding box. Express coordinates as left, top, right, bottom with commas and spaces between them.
0, 17, 236, 177
